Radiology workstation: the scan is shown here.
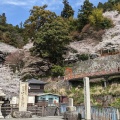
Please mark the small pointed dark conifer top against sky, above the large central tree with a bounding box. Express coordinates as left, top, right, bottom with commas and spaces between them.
61, 0, 74, 18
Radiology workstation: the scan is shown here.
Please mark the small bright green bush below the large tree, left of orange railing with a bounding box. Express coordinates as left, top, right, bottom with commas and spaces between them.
51, 65, 64, 77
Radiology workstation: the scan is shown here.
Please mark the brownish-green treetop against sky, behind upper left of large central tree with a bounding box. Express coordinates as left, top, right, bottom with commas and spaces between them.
24, 5, 56, 38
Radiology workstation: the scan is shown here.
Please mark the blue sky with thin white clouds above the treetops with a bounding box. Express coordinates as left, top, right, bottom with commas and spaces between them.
0, 0, 108, 26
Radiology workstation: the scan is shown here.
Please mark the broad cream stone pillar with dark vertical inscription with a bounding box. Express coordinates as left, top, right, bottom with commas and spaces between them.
19, 82, 28, 111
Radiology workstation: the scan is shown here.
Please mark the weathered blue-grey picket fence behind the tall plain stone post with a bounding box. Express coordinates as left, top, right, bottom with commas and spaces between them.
60, 104, 118, 120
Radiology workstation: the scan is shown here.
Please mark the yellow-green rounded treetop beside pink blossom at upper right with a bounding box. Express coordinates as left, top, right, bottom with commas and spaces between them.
89, 8, 113, 29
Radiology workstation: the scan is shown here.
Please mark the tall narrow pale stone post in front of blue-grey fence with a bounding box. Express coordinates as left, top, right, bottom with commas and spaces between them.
83, 77, 91, 120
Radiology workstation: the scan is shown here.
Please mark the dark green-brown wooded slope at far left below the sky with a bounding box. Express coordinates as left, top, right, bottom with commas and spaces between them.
0, 13, 25, 48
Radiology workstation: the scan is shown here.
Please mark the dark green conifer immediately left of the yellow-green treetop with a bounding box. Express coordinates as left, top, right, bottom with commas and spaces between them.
78, 0, 93, 30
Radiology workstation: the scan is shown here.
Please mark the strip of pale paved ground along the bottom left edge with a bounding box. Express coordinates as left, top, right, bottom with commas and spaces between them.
0, 116, 63, 120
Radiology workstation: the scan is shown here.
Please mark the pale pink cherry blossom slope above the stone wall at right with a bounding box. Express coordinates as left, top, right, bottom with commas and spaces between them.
68, 11, 120, 61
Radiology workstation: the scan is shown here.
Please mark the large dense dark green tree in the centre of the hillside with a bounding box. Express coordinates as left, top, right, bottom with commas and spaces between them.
32, 17, 70, 65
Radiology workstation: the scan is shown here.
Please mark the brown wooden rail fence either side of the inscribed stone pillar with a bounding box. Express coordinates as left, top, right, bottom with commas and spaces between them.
1, 103, 59, 117
